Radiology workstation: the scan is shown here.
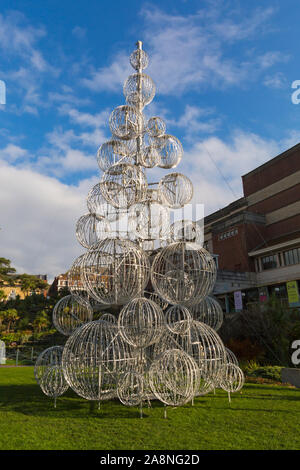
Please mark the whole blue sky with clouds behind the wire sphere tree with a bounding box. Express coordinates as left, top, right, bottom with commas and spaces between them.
0, 0, 300, 277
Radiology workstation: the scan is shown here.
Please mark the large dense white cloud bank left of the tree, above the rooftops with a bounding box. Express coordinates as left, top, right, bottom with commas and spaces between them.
0, 161, 87, 278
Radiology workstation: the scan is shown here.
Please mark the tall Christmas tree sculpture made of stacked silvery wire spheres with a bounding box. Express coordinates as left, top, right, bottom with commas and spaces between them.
35, 41, 243, 416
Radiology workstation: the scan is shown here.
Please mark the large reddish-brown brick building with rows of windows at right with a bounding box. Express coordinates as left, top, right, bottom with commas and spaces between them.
204, 144, 300, 311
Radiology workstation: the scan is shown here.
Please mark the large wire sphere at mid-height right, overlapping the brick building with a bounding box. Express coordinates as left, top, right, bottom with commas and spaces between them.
151, 242, 217, 305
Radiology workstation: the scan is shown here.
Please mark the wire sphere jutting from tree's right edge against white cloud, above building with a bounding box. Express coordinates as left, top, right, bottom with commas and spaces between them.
158, 173, 194, 209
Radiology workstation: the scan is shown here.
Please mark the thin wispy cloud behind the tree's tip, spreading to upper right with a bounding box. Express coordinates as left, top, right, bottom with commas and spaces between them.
82, 2, 288, 95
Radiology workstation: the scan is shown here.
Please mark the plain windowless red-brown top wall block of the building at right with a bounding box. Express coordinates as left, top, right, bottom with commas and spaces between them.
242, 146, 300, 196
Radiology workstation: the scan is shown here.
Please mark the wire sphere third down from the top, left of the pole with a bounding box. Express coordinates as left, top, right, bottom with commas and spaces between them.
109, 105, 145, 140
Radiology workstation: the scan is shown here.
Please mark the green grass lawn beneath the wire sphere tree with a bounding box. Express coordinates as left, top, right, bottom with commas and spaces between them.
0, 367, 300, 450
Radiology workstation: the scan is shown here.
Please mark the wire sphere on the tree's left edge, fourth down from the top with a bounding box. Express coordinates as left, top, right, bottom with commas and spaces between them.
97, 140, 132, 171
